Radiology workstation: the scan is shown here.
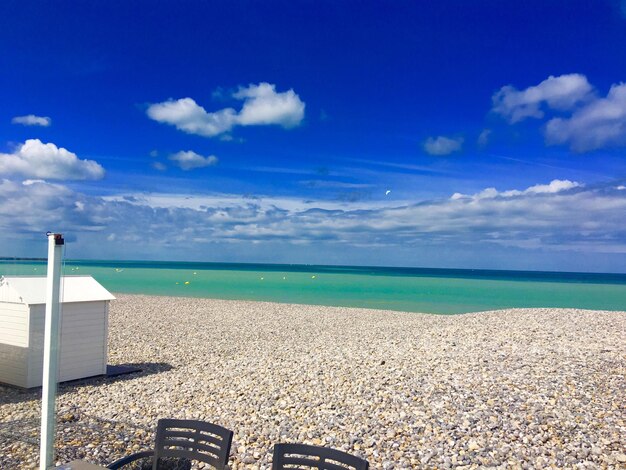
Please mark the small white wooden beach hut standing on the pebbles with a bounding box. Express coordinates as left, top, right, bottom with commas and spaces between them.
0, 276, 115, 388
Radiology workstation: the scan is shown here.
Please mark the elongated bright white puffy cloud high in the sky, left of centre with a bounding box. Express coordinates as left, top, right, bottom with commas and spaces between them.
146, 82, 305, 137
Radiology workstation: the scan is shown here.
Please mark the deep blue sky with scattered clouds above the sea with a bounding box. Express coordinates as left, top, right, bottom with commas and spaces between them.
0, 0, 626, 272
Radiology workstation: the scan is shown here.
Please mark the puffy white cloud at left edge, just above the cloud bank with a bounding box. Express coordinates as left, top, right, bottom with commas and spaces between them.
0, 139, 104, 180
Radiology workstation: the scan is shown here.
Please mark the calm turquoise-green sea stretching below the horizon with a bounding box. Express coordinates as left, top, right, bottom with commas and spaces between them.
0, 260, 626, 314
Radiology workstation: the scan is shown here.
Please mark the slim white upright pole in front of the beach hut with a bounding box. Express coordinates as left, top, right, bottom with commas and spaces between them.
39, 232, 64, 470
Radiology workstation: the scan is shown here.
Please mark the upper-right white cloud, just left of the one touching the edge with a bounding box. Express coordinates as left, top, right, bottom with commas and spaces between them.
492, 73, 593, 124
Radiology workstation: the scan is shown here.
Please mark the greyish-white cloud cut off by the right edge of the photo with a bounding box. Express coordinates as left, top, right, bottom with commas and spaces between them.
546, 83, 626, 152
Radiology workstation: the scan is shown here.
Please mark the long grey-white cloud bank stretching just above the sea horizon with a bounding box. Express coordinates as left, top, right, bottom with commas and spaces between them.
0, 180, 626, 254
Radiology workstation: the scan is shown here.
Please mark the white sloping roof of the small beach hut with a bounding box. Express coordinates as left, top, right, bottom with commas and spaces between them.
0, 276, 115, 305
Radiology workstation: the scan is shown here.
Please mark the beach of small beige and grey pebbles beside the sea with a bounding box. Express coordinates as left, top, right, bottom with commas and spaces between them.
0, 295, 626, 469
